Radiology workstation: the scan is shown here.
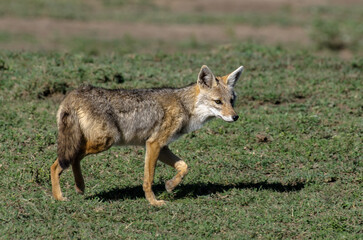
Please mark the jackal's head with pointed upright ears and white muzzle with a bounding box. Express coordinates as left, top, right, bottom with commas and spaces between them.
196, 65, 243, 122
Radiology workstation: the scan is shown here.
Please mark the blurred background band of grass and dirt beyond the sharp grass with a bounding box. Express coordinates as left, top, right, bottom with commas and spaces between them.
0, 0, 363, 59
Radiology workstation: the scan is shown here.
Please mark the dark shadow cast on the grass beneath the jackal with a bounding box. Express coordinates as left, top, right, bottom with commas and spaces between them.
86, 182, 305, 201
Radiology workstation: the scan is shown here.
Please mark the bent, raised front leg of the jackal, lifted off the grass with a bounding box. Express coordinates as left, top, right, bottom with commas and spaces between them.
159, 146, 188, 193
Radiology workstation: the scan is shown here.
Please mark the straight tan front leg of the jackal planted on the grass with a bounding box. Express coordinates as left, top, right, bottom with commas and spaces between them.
143, 141, 165, 206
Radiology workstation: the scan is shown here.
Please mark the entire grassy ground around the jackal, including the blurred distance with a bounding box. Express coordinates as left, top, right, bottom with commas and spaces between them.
0, 0, 363, 239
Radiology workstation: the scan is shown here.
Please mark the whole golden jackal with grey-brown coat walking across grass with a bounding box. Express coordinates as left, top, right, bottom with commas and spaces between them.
51, 66, 243, 206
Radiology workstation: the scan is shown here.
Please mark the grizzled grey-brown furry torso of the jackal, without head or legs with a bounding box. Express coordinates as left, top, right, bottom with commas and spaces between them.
57, 86, 191, 147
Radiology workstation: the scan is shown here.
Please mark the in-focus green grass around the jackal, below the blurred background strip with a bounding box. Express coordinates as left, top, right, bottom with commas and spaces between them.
0, 44, 363, 239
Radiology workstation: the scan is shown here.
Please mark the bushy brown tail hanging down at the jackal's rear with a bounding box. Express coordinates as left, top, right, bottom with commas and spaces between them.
57, 109, 83, 169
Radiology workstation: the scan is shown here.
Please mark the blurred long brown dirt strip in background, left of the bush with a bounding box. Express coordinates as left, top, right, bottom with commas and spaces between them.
0, 18, 309, 50
